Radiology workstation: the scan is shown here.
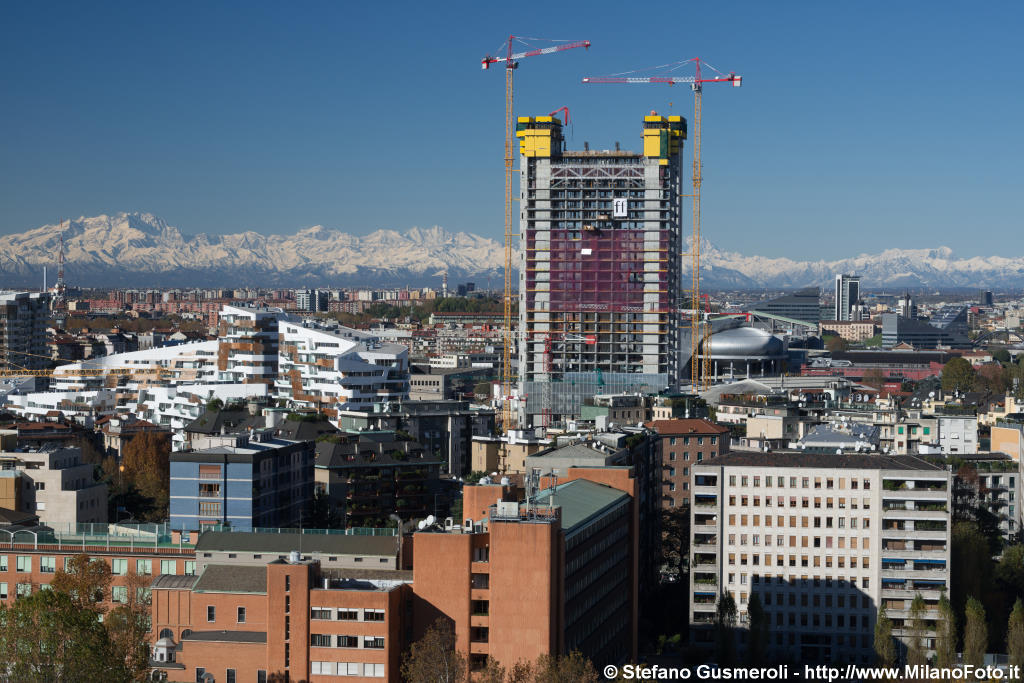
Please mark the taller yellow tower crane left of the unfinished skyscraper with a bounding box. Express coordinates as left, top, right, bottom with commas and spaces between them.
480, 36, 590, 432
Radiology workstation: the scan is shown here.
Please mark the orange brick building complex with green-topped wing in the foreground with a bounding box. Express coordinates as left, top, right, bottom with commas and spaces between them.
152, 467, 640, 683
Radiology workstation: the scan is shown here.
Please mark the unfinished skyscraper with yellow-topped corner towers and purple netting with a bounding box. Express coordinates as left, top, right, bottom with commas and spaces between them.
516, 113, 688, 426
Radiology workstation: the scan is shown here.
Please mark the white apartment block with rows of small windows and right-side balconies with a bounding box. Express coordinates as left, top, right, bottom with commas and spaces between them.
689, 452, 952, 664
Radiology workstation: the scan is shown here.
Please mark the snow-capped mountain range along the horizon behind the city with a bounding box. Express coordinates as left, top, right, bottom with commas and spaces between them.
0, 213, 1024, 289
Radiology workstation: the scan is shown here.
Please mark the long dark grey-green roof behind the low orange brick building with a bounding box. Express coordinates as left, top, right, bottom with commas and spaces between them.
196, 529, 398, 556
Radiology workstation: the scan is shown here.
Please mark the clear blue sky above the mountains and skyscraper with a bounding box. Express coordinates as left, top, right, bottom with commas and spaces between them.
0, 0, 1024, 258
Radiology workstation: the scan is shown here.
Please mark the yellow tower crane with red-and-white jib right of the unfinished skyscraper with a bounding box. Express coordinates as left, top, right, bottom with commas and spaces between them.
583, 57, 742, 391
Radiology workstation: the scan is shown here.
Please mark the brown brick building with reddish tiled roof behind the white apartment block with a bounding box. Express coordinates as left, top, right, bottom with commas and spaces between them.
647, 419, 729, 508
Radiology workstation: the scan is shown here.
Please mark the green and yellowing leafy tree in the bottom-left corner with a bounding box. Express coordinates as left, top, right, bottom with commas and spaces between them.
0, 590, 131, 683
